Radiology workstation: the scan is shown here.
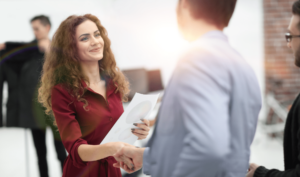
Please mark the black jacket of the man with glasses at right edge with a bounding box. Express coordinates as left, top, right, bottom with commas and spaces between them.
254, 94, 300, 177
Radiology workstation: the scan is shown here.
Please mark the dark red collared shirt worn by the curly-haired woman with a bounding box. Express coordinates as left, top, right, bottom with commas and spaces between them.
51, 81, 124, 177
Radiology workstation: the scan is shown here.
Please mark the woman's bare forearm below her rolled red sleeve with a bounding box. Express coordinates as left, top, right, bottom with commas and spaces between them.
78, 143, 113, 162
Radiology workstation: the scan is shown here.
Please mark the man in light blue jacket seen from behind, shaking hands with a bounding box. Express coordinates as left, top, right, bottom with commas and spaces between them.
114, 0, 261, 177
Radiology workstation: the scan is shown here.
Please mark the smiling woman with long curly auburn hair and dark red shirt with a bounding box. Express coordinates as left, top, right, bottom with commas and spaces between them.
39, 14, 149, 177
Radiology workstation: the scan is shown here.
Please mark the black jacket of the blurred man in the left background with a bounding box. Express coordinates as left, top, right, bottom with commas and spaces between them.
0, 41, 46, 128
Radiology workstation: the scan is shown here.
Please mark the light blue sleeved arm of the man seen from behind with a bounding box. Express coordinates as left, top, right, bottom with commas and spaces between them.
172, 54, 231, 177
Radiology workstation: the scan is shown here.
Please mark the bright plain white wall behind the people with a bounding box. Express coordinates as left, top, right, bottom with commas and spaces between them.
0, 0, 263, 87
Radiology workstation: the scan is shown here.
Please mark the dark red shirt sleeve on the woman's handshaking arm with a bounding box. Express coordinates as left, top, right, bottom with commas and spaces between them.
51, 85, 87, 168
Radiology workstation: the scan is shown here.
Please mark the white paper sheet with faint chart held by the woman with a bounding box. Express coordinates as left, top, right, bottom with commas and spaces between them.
100, 93, 159, 145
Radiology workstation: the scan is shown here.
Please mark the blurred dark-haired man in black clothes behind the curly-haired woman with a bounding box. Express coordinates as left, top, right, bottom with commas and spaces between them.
0, 15, 67, 177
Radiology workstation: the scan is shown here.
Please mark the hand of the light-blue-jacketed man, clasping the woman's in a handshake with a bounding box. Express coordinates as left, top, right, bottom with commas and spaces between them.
113, 146, 145, 173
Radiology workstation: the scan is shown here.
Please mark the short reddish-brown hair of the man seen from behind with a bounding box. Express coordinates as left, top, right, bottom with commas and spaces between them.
187, 0, 237, 28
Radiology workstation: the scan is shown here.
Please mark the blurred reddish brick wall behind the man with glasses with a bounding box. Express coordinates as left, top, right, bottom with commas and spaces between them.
263, 0, 300, 105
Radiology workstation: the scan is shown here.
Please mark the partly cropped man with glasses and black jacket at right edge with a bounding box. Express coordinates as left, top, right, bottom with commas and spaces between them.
247, 0, 300, 177
